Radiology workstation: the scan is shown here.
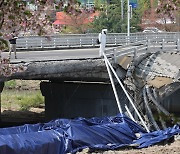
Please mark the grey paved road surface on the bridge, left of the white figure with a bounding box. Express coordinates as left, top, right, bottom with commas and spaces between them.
2, 48, 99, 62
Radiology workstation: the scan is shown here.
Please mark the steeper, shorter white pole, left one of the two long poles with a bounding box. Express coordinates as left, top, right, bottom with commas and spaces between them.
103, 53, 122, 113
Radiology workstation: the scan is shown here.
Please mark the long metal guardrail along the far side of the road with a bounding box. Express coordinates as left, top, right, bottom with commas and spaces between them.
17, 32, 180, 49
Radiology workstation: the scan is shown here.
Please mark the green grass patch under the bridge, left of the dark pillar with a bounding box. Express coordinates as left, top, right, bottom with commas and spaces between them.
1, 90, 44, 110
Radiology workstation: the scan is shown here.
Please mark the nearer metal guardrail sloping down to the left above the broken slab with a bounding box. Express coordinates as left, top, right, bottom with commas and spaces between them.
105, 38, 180, 62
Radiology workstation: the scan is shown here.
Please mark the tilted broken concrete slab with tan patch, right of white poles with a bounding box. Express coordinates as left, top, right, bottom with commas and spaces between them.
124, 51, 180, 88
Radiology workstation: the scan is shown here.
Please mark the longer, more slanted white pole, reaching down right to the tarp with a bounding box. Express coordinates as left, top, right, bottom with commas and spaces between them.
103, 53, 150, 132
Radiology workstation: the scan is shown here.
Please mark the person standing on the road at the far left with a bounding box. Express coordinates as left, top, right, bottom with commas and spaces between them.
9, 31, 18, 59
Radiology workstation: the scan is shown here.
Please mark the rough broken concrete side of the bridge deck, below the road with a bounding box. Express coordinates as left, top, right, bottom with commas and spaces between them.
0, 58, 125, 82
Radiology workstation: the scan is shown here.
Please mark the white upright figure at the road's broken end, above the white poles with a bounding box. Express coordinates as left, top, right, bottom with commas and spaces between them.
98, 29, 107, 57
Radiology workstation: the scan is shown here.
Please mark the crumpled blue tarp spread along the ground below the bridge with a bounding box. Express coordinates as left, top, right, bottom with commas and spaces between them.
0, 114, 180, 154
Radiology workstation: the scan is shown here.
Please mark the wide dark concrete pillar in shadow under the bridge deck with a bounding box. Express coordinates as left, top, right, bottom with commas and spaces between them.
40, 82, 127, 120
